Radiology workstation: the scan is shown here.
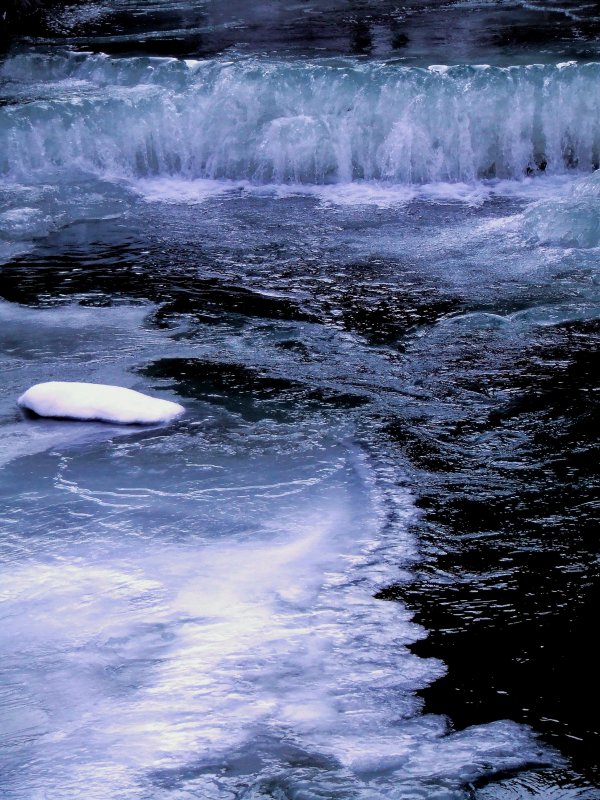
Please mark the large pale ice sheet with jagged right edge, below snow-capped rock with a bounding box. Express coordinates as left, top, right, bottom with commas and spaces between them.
0, 296, 548, 798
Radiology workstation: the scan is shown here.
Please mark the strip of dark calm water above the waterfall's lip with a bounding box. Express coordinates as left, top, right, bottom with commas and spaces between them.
8, 0, 600, 64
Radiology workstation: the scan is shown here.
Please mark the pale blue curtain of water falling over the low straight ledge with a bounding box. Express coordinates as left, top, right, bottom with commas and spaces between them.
0, 54, 600, 184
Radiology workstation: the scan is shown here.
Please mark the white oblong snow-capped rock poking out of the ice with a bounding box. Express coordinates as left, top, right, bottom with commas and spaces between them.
17, 381, 185, 425
